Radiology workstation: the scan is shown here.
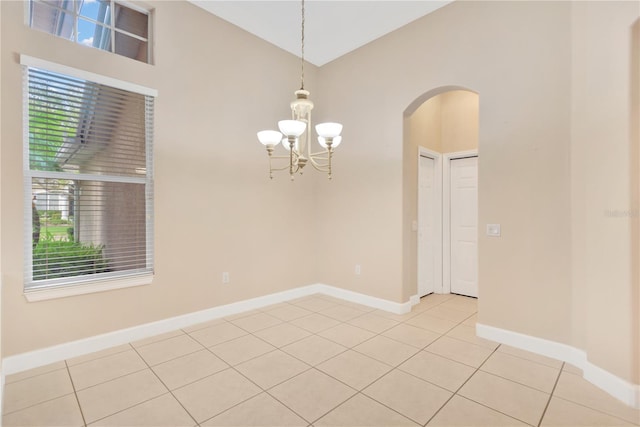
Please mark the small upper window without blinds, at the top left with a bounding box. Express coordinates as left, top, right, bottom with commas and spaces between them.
28, 0, 151, 63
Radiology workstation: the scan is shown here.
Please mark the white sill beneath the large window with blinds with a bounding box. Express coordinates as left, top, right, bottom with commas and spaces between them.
24, 273, 153, 302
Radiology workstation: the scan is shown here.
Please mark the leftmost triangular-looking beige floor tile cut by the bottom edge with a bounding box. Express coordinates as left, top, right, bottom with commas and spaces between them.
90, 393, 196, 427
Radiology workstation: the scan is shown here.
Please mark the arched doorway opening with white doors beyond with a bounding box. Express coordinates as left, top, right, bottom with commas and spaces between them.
404, 87, 479, 297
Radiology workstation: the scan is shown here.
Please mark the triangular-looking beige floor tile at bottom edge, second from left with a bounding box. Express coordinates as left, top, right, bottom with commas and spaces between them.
201, 393, 309, 427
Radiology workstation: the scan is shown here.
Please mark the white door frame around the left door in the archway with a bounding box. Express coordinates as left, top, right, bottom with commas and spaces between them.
416, 147, 444, 295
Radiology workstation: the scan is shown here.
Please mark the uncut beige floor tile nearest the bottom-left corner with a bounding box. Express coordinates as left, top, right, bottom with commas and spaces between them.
77, 369, 167, 423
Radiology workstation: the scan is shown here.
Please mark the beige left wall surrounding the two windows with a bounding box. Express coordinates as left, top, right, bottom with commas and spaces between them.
0, 1, 317, 357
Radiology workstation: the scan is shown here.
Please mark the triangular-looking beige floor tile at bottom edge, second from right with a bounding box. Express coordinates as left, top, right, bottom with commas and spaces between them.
427, 396, 528, 427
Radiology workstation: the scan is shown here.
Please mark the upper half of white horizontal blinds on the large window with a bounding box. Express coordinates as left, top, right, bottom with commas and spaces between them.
29, 68, 146, 177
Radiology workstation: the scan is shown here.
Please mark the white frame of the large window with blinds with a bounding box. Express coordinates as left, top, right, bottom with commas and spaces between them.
20, 55, 158, 301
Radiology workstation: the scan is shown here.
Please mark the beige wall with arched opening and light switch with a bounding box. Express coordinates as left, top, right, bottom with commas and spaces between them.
319, 2, 571, 342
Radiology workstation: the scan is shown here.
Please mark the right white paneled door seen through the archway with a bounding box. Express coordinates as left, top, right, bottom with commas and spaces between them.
450, 157, 478, 297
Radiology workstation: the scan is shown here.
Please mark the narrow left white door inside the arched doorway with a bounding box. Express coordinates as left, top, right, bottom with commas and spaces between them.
418, 156, 441, 297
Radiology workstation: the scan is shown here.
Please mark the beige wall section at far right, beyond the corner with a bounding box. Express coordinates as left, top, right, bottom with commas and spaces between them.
570, 2, 640, 384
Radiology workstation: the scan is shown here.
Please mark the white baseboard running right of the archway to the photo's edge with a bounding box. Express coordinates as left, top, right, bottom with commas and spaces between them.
476, 323, 640, 409
